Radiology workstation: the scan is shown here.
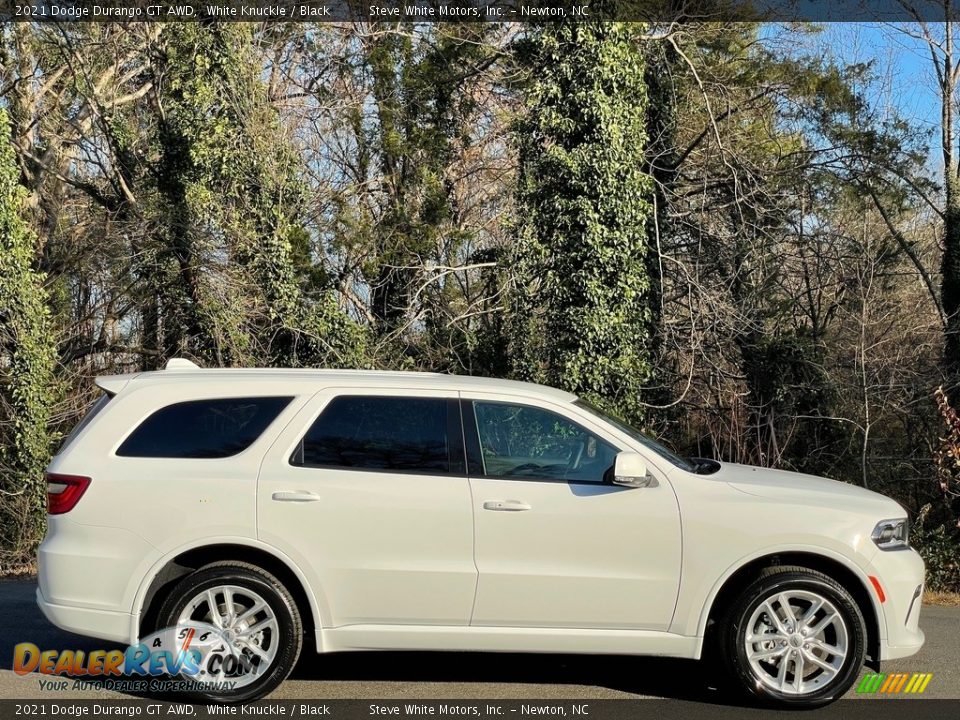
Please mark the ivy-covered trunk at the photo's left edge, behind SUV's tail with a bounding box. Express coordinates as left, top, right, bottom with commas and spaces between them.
0, 109, 56, 573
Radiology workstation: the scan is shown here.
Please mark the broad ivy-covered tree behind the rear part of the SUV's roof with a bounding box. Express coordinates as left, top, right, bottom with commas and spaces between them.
141, 23, 363, 366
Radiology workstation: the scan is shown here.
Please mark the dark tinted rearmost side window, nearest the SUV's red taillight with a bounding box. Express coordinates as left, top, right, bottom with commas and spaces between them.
117, 397, 293, 458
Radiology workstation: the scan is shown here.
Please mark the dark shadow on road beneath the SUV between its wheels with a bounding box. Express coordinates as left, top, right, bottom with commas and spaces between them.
291, 652, 740, 705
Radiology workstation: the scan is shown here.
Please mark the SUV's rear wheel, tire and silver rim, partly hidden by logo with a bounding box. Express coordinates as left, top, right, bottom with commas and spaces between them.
159, 562, 303, 702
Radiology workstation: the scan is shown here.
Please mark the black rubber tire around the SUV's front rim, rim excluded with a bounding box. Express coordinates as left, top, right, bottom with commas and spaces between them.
727, 573, 867, 707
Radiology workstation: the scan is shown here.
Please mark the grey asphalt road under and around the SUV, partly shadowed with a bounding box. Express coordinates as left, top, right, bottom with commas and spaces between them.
0, 580, 960, 704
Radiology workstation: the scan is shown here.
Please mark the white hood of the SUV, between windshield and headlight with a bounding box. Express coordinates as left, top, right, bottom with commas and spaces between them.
705, 463, 906, 520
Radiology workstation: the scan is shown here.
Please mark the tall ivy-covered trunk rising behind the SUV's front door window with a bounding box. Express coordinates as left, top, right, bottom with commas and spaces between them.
515, 22, 658, 421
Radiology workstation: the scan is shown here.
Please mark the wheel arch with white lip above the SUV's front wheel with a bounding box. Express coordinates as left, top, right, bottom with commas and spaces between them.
698, 550, 886, 665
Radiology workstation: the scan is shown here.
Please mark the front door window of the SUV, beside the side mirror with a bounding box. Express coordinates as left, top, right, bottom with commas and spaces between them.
472, 400, 617, 483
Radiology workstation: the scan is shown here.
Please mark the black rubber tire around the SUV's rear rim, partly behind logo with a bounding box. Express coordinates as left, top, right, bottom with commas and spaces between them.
158, 561, 303, 703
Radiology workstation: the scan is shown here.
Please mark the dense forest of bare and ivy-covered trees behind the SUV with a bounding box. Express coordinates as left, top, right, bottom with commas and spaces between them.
0, 22, 960, 590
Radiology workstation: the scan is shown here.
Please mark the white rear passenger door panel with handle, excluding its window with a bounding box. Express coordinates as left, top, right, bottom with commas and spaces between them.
257, 387, 477, 627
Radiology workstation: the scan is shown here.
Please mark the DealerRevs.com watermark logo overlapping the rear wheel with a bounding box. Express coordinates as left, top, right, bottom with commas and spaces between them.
13, 622, 262, 692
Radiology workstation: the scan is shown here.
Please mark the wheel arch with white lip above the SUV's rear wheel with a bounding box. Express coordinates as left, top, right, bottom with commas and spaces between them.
131, 539, 321, 650
